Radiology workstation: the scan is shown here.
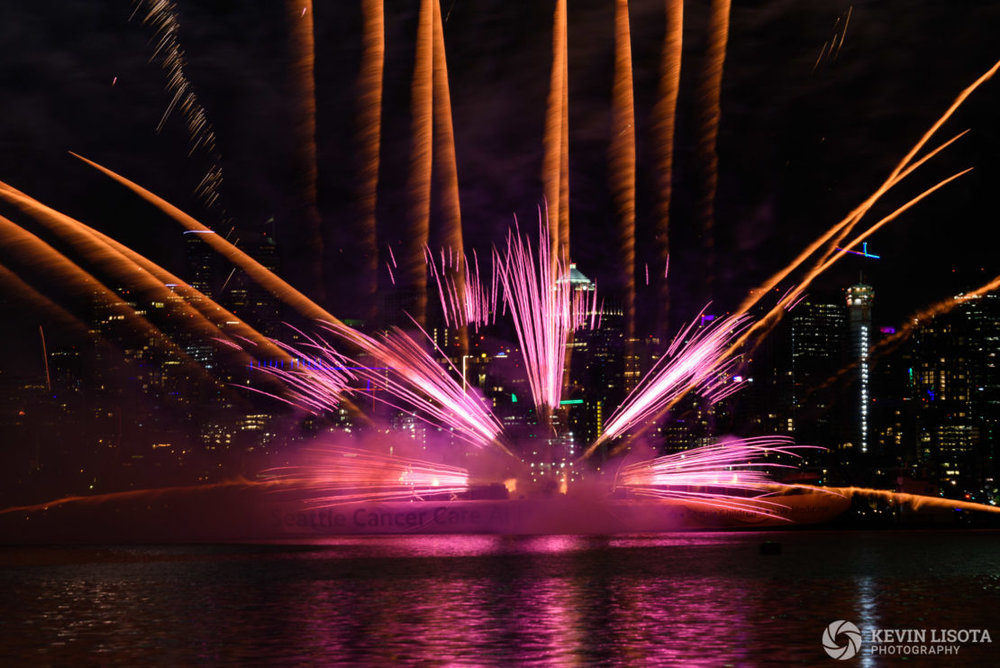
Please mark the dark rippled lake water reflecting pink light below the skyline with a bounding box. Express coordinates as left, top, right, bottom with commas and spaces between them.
0, 531, 1000, 666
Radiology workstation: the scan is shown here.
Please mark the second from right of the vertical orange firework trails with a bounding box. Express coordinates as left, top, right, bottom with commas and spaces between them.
654, 0, 684, 335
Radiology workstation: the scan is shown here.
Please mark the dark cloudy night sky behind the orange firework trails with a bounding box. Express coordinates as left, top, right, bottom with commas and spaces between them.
0, 0, 1000, 376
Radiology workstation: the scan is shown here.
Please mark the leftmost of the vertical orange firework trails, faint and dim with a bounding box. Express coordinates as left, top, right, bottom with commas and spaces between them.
285, 0, 324, 300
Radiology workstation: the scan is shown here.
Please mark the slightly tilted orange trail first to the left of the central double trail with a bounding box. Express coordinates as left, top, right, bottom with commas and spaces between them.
433, 0, 469, 355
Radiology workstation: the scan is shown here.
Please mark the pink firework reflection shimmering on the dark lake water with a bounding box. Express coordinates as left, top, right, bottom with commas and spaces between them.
274, 532, 754, 666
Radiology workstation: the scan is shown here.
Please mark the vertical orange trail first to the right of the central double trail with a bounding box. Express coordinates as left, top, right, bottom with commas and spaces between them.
611, 0, 635, 341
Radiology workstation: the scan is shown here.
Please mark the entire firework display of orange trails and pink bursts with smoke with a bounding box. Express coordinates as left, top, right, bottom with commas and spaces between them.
0, 0, 1000, 534
